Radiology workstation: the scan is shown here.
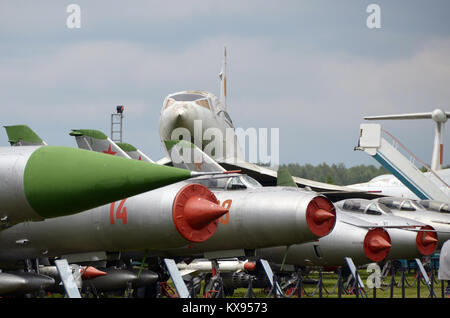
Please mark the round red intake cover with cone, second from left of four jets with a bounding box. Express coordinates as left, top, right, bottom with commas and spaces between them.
306, 197, 336, 237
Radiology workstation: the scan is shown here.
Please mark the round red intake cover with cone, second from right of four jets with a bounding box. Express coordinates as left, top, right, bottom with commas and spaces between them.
363, 228, 392, 262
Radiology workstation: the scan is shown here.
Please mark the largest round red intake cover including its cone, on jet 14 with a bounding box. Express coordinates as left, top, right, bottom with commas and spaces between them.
172, 184, 228, 243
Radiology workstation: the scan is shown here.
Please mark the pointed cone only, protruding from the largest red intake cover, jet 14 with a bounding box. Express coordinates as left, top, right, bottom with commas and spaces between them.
184, 196, 228, 230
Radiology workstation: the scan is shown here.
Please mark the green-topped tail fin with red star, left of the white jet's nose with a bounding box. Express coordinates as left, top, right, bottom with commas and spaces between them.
69, 129, 131, 159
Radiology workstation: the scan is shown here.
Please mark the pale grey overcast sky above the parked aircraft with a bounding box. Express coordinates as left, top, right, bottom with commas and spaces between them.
0, 0, 450, 167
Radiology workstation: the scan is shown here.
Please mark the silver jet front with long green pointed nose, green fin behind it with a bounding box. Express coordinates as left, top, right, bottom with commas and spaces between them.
0, 126, 206, 228
